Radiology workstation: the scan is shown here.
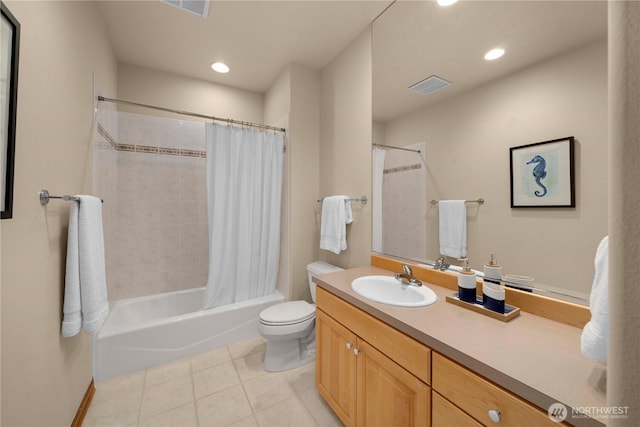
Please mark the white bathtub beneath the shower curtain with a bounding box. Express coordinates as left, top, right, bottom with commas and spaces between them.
93, 288, 284, 382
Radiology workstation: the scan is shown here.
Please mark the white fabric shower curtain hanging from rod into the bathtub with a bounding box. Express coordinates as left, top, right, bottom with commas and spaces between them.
204, 123, 284, 308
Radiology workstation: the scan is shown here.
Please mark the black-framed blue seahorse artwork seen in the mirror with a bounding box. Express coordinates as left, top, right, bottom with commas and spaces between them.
509, 136, 576, 208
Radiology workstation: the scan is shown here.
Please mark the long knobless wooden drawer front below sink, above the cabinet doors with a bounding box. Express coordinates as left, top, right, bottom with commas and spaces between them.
316, 287, 431, 384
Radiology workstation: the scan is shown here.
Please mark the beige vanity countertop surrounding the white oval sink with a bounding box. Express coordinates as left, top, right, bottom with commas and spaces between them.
314, 266, 606, 426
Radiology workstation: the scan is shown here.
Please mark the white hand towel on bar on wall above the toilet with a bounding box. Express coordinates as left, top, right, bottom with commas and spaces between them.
320, 196, 353, 254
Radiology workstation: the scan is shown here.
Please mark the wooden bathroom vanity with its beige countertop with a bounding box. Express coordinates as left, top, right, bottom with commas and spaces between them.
314, 267, 606, 427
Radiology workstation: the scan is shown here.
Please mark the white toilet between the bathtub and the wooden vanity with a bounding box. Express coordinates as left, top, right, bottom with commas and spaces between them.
258, 261, 342, 372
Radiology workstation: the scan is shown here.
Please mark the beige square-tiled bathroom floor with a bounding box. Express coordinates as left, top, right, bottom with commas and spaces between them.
83, 338, 342, 427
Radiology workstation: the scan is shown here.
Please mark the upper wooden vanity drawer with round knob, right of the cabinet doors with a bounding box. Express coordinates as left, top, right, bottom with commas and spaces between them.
433, 353, 558, 427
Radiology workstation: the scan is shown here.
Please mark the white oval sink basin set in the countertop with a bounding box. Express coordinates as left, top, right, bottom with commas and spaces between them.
351, 276, 438, 307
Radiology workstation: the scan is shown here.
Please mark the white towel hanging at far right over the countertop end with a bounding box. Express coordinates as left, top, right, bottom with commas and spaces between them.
580, 236, 609, 362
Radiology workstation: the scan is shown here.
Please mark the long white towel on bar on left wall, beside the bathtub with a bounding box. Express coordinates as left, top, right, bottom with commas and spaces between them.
62, 196, 109, 337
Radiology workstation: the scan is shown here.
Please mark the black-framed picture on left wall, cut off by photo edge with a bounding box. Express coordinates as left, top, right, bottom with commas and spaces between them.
0, 3, 20, 219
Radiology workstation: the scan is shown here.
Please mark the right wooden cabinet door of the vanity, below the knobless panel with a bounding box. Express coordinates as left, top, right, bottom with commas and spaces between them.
356, 339, 431, 427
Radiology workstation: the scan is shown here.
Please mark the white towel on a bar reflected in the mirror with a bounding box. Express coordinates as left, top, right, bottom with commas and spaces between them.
438, 200, 467, 258
